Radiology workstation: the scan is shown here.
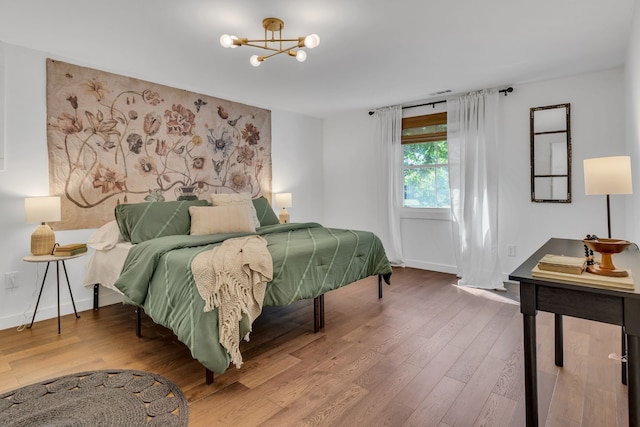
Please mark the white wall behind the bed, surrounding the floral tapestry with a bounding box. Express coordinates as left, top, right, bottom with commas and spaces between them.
0, 44, 323, 329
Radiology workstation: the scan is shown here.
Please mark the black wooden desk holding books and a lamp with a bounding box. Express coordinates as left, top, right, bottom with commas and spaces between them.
509, 239, 640, 427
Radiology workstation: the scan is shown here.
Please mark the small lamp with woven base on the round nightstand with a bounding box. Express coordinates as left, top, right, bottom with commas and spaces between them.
24, 196, 61, 255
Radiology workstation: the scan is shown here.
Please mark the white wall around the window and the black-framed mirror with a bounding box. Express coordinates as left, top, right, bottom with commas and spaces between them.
324, 68, 628, 278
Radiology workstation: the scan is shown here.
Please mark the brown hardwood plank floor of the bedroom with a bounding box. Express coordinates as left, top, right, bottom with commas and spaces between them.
0, 268, 628, 427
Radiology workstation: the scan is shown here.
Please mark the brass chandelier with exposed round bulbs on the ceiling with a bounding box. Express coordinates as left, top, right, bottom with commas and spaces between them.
220, 18, 320, 67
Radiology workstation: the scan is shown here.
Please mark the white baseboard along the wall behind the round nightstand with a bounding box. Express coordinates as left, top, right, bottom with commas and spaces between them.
0, 288, 122, 330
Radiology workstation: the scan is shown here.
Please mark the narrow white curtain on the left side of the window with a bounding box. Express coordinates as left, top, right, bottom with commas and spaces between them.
375, 105, 404, 267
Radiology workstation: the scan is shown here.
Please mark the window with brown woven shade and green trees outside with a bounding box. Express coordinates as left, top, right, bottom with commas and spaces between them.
402, 112, 450, 208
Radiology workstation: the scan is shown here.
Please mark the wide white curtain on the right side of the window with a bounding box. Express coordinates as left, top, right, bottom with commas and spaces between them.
447, 90, 504, 289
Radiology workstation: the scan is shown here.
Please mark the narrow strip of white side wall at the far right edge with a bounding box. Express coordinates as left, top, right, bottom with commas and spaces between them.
625, 1, 640, 243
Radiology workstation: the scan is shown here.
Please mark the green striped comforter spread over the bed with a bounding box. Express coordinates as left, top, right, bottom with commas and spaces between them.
115, 223, 391, 373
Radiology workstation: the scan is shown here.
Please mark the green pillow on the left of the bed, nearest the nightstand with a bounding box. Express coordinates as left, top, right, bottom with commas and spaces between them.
115, 200, 209, 243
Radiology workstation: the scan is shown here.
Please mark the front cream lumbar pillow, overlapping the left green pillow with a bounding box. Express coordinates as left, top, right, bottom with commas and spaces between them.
189, 205, 256, 236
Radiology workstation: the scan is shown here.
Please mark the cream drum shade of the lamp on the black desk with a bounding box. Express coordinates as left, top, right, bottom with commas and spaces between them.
584, 156, 633, 195
